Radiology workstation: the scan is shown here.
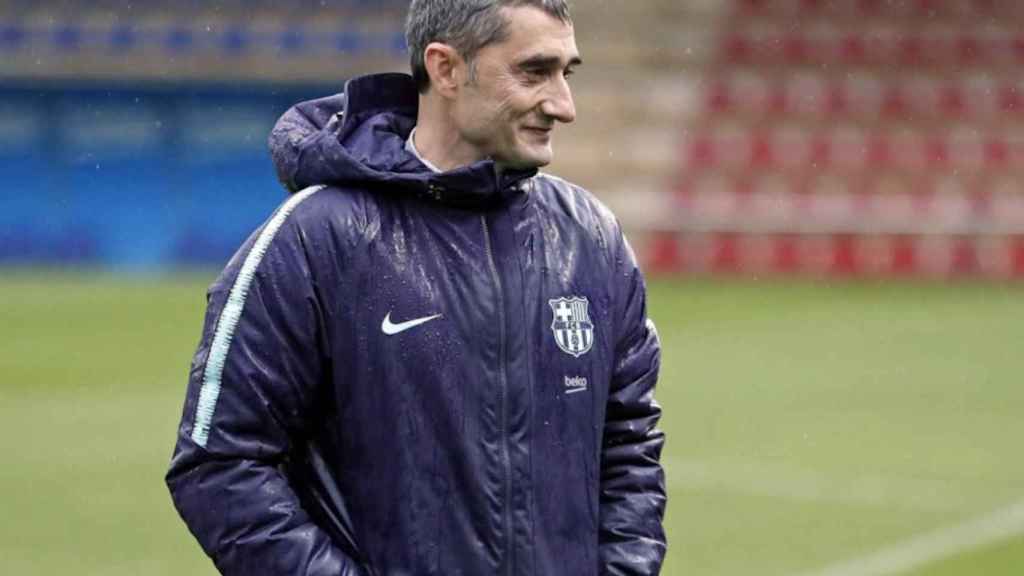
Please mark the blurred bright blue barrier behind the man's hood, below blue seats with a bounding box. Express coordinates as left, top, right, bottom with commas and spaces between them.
0, 85, 337, 271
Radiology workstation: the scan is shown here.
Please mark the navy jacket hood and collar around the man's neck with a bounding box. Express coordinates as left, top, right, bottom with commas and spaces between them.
269, 74, 537, 207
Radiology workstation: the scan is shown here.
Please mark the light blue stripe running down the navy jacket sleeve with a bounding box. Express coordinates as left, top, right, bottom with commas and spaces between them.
191, 186, 325, 448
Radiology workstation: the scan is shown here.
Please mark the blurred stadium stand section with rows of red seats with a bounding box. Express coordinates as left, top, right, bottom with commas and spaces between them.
652, 0, 1024, 277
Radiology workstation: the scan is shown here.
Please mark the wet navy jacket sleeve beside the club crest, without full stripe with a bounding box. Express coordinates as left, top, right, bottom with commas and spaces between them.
600, 229, 666, 576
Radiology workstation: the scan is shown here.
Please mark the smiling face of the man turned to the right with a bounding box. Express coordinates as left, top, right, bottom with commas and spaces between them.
454, 6, 581, 168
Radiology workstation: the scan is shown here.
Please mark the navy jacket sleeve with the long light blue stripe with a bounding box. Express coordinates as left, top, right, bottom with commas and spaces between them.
166, 202, 364, 576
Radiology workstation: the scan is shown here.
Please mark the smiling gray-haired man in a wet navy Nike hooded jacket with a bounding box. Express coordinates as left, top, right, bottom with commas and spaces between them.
167, 0, 666, 576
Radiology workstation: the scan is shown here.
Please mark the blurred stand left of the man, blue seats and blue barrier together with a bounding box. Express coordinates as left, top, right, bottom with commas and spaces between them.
0, 0, 408, 270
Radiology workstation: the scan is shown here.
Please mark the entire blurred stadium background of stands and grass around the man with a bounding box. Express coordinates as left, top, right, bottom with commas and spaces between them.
0, 0, 1024, 576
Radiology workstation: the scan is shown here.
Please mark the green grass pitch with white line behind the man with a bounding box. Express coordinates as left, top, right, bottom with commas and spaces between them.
0, 270, 1024, 576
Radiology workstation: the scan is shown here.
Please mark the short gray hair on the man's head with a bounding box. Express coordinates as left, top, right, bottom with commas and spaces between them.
406, 0, 572, 93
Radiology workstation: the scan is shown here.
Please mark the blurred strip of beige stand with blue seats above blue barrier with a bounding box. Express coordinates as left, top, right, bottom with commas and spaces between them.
0, 0, 406, 82
